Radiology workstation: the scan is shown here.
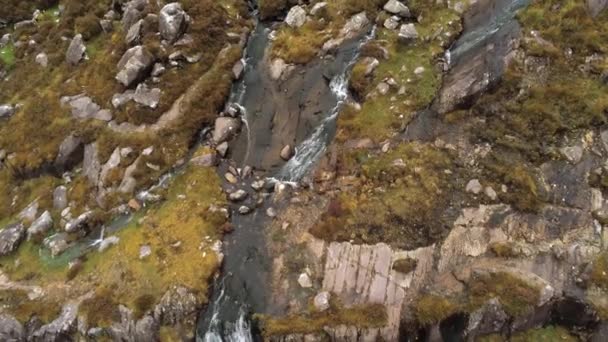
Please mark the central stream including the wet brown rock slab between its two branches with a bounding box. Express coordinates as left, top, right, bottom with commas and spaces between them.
197, 8, 374, 342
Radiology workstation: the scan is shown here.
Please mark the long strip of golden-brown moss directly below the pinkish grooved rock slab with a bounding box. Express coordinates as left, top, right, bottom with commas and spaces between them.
256, 300, 387, 338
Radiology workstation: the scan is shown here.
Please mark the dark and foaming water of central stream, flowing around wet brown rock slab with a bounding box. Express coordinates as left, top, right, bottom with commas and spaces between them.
197, 13, 374, 342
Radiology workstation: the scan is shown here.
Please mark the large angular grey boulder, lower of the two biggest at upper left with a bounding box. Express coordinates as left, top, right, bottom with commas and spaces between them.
116, 45, 154, 87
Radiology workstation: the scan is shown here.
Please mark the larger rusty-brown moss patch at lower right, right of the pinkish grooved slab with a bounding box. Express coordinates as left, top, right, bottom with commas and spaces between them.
468, 272, 540, 317
